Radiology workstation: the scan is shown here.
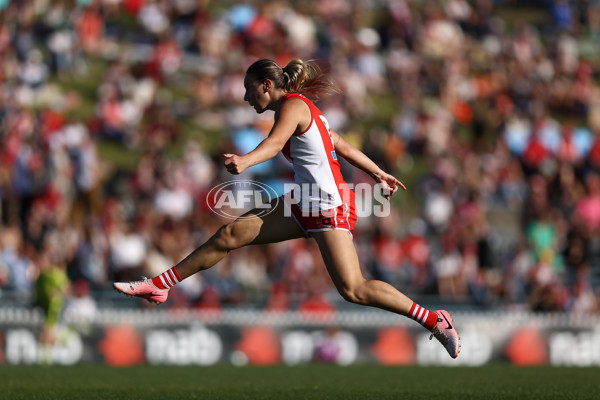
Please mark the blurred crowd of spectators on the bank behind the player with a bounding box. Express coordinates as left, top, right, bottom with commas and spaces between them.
0, 0, 600, 315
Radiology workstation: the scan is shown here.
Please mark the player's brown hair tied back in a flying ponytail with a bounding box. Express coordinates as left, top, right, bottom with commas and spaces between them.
244, 58, 339, 106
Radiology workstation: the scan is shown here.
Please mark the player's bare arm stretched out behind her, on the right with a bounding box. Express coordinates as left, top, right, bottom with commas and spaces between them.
330, 131, 406, 198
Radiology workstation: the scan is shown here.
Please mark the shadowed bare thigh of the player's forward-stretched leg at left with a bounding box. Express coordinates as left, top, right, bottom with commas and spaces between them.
234, 195, 306, 244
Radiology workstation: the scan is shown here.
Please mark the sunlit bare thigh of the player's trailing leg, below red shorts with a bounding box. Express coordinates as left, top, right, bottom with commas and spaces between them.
311, 229, 365, 290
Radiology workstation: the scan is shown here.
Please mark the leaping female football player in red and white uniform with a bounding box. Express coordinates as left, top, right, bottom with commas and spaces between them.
113, 59, 460, 358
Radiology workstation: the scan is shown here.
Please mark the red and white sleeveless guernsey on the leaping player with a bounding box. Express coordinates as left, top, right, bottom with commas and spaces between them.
282, 93, 354, 213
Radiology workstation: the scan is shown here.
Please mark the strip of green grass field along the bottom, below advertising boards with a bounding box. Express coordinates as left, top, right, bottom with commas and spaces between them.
0, 365, 600, 400
